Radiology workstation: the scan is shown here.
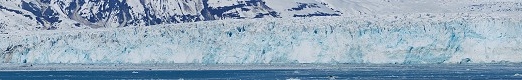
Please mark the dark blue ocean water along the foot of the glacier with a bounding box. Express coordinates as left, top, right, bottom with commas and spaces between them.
0, 64, 522, 80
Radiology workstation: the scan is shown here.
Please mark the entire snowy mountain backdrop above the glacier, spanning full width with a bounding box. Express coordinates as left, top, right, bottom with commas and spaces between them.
4, 0, 522, 34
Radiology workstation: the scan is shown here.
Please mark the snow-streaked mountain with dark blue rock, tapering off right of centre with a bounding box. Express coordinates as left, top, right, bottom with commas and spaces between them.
0, 0, 342, 33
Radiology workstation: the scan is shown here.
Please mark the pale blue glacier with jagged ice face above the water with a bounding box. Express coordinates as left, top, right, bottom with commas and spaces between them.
0, 14, 522, 64
